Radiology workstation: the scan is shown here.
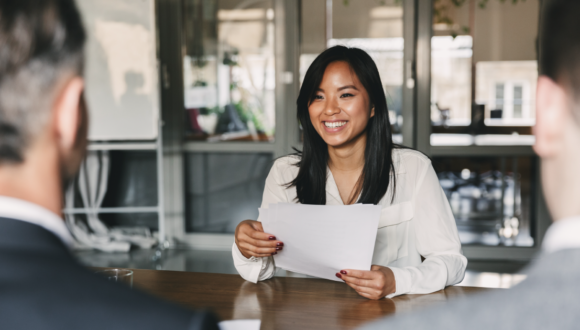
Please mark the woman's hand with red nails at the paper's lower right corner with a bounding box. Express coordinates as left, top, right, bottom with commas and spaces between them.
336, 265, 397, 300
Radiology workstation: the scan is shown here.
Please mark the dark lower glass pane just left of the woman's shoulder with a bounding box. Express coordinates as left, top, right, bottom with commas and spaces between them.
185, 153, 273, 233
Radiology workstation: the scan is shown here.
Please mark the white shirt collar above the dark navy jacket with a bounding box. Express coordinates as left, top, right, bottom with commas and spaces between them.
0, 196, 73, 247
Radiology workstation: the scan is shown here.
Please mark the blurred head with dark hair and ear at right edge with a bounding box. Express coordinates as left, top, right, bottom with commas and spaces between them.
534, 0, 580, 222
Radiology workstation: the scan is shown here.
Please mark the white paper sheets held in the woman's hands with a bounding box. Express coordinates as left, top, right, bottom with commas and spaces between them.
259, 203, 381, 281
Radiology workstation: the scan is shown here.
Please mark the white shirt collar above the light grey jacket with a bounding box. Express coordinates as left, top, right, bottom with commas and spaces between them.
542, 216, 580, 253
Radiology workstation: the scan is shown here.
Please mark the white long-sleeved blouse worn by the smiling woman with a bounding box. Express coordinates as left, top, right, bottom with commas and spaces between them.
232, 149, 467, 298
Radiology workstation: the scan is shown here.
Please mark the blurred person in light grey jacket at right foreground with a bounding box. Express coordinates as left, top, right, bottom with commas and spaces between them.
364, 0, 580, 330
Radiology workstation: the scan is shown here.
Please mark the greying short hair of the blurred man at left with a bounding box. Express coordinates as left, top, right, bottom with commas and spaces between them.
0, 0, 86, 164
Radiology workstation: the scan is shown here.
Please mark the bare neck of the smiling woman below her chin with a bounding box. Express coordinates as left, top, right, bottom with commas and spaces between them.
328, 132, 367, 172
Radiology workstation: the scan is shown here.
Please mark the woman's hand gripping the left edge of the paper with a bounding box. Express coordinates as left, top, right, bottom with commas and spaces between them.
235, 220, 284, 258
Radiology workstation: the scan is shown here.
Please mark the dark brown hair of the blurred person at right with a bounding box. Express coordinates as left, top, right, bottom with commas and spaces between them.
540, 0, 580, 101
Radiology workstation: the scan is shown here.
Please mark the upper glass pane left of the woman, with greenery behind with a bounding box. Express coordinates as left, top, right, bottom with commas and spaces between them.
183, 0, 275, 142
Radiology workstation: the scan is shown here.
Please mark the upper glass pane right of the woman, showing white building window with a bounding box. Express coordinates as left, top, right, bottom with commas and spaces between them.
431, 0, 539, 145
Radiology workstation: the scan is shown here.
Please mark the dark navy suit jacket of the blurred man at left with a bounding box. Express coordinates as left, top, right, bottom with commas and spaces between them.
0, 218, 218, 330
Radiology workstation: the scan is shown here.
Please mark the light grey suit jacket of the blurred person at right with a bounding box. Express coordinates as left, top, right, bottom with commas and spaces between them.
363, 249, 580, 330
